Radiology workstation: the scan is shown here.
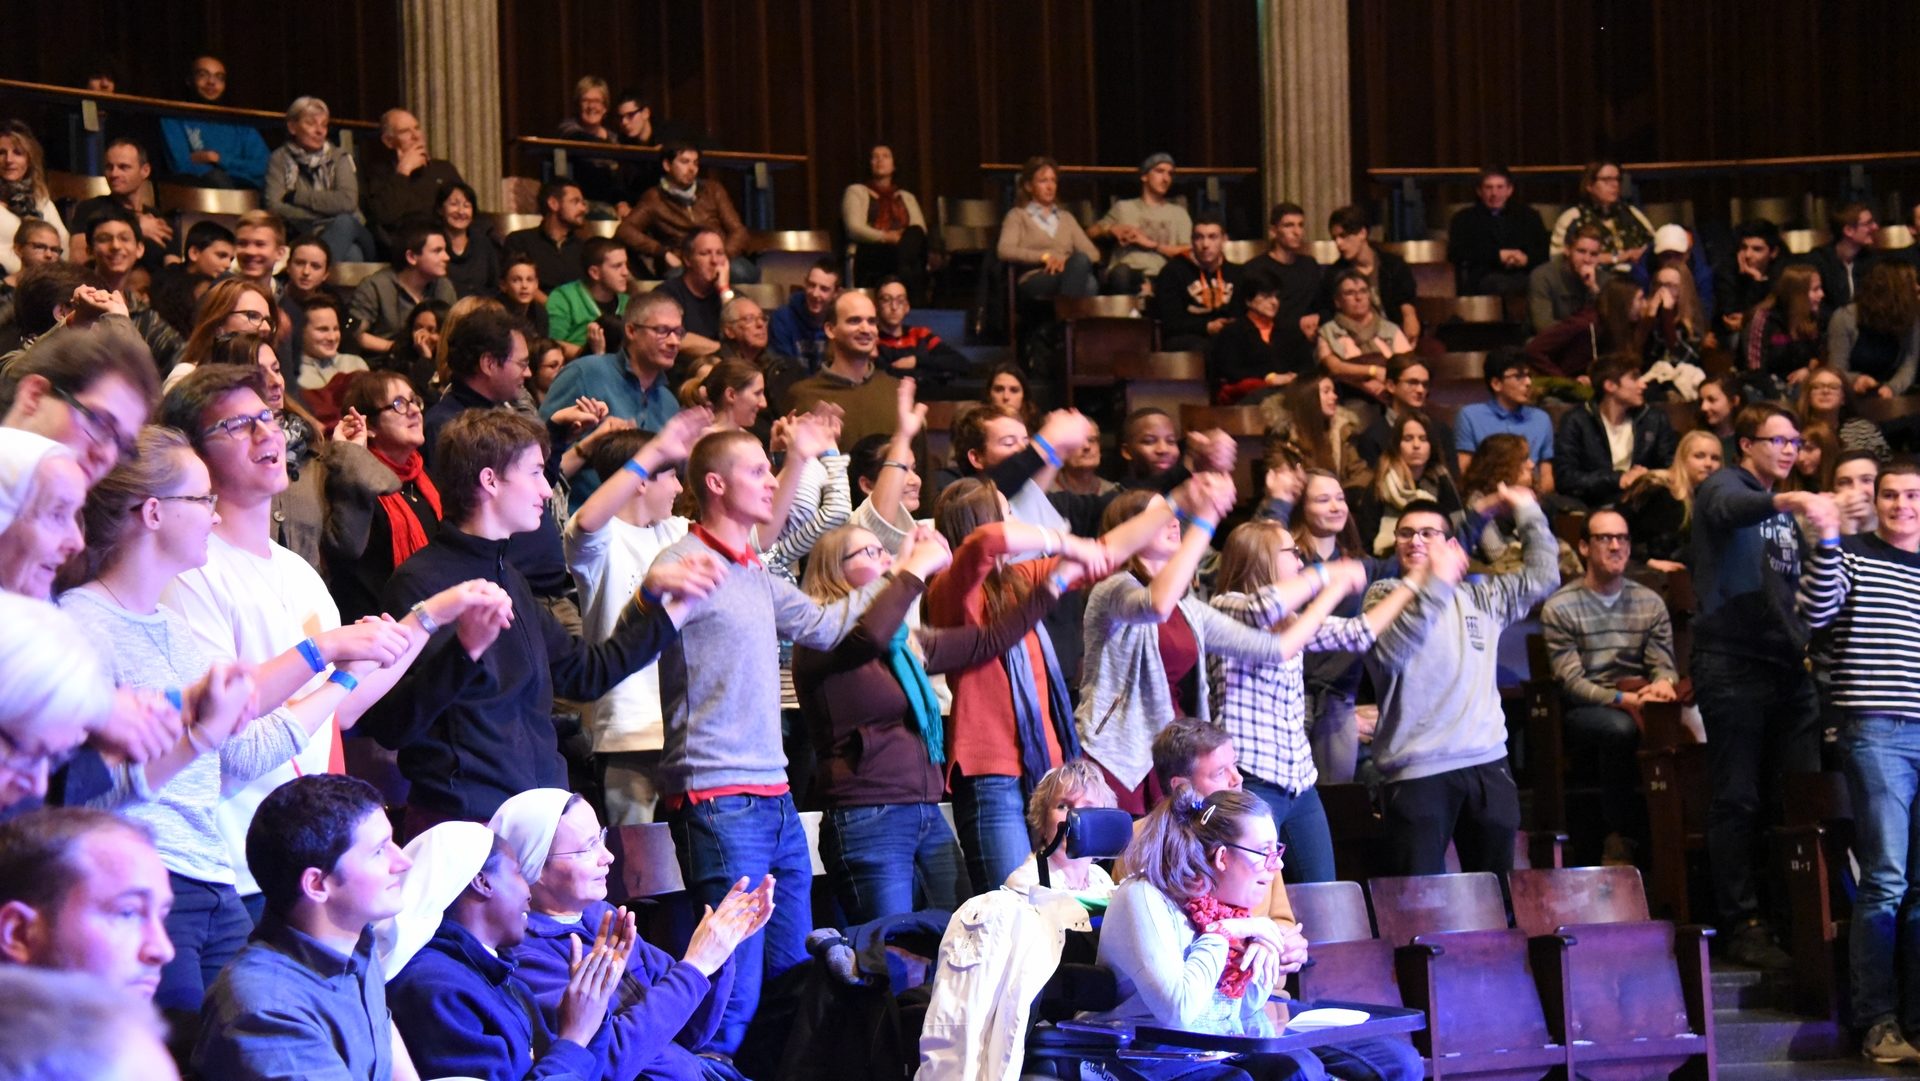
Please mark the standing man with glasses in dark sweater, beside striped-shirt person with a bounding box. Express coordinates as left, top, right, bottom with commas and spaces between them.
1688, 403, 1839, 968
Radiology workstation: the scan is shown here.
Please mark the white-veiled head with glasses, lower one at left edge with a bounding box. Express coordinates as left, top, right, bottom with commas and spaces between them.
0, 593, 113, 812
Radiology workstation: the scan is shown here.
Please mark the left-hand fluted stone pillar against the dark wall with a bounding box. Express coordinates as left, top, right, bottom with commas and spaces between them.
401, 0, 505, 209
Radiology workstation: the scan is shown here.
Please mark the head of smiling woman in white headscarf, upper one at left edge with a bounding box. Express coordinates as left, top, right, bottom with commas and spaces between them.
0, 428, 86, 601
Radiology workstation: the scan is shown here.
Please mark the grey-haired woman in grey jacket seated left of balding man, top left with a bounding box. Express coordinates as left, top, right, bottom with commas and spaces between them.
265, 96, 374, 263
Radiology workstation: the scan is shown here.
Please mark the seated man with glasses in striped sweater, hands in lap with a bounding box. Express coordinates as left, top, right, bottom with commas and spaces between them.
1540, 511, 1680, 864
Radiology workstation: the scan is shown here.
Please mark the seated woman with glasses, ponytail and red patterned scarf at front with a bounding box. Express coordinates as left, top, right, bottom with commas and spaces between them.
1098, 783, 1423, 1081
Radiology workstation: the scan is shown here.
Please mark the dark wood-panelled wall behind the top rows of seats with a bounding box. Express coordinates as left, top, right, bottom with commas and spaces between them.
15, 0, 1920, 225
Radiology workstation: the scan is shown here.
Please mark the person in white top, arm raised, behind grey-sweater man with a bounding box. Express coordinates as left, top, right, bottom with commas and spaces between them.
561, 409, 712, 826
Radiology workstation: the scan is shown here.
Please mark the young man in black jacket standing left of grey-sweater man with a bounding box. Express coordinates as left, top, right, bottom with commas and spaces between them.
361, 409, 722, 835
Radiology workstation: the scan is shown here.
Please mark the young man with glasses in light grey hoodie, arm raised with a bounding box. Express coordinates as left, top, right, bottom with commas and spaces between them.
1367, 484, 1559, 874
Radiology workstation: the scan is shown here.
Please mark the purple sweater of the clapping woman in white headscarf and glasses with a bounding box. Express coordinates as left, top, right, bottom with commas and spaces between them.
513, 901, 733, 1081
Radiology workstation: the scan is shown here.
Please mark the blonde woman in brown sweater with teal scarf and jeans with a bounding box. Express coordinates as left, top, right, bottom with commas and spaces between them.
793, 526, 1058, 924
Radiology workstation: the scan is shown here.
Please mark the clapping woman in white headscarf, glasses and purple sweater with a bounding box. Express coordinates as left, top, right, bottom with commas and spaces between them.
492, 789, 774, 1081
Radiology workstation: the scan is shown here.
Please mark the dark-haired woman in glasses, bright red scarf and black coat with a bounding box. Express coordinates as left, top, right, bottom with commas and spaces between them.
321, 372, 440, 622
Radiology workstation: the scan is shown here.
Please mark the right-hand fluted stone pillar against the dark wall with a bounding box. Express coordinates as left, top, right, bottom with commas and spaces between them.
1260, 0, 1354, 238
